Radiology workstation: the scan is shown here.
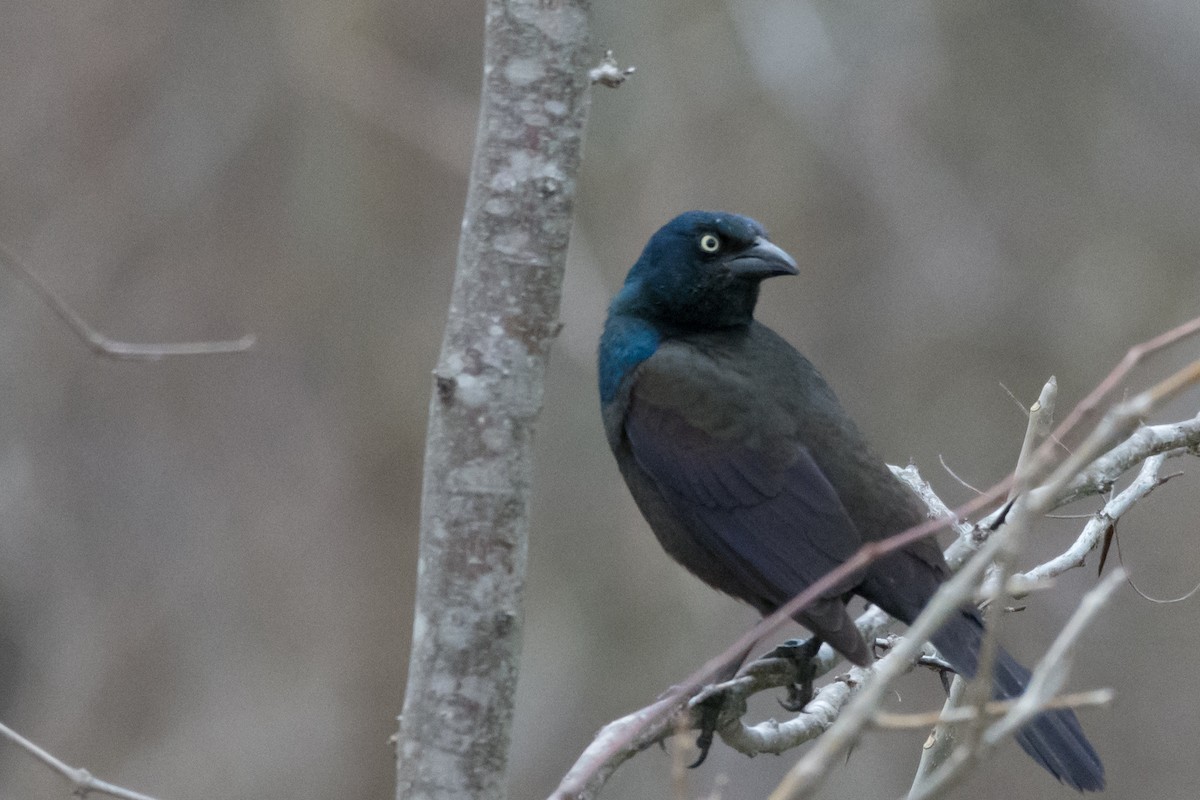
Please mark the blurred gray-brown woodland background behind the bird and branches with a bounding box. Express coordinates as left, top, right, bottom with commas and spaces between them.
0, 0, 1200, 800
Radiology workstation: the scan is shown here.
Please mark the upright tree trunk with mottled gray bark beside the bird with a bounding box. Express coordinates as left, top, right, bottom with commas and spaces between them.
396, 0, 589, 800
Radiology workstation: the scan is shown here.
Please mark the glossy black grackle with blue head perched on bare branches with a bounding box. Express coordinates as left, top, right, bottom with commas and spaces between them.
599, 211, 1104, 790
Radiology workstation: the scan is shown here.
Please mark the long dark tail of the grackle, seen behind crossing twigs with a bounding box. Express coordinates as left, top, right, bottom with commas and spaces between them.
932, 612, 1104, 792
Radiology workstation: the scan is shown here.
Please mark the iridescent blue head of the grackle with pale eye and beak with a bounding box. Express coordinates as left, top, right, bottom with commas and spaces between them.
612, 211, 797, 330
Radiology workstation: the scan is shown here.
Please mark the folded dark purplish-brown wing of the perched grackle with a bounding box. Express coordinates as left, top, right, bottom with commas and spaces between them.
624, 348, 863, 608
